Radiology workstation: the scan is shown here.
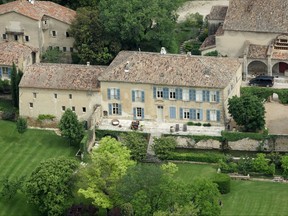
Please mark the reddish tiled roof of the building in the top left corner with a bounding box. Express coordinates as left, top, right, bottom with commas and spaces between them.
0, 0, 76, 24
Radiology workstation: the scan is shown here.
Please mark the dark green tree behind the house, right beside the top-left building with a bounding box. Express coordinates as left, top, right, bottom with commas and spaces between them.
69, 8, 121, 64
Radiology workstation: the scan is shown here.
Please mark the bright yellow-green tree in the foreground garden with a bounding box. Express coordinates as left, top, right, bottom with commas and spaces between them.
78, 137, 134, 210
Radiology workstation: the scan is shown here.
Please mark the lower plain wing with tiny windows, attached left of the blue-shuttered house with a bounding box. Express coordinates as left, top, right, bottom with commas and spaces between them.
19, 63, 106, 121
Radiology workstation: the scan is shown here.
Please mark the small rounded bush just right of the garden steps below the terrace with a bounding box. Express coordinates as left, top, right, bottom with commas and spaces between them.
153, 137, 177, 160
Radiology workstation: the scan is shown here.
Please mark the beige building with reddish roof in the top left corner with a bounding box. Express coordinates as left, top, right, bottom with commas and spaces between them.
0, 0, 76, 55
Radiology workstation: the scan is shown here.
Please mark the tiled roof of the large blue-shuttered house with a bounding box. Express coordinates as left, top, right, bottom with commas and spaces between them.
99, 51, 241, 88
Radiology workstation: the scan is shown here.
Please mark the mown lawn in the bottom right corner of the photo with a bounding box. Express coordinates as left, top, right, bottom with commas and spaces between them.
222, 181, 288, 216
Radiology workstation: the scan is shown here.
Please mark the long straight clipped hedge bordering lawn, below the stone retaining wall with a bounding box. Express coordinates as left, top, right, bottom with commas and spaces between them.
168, 152, 226, 163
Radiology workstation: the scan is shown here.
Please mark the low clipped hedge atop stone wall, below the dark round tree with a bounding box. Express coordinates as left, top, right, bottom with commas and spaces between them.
221, 131, 265, 141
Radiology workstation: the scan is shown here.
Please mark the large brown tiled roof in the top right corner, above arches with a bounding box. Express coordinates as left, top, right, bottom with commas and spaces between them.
223, 0, 288, 33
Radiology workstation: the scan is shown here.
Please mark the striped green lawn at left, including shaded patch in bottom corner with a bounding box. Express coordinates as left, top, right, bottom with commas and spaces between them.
0, 120, 77, 216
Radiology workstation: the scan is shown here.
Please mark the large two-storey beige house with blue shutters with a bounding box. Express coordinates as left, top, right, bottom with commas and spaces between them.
99, 51, 242, 126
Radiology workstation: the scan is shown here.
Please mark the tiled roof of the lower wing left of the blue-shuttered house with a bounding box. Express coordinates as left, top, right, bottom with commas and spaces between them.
19, 63, 107, 90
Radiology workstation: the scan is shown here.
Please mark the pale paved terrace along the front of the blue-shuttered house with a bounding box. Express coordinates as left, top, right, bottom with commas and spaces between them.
99, 119, 225, 136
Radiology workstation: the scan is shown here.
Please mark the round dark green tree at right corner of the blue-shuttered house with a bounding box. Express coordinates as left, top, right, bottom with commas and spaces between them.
228, 95, 265, 132
